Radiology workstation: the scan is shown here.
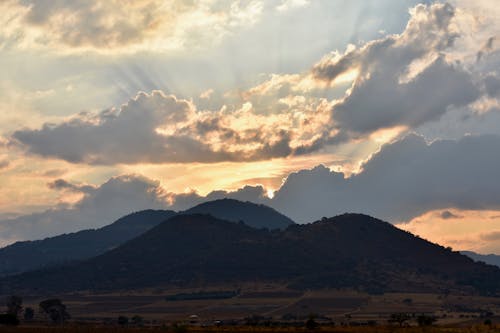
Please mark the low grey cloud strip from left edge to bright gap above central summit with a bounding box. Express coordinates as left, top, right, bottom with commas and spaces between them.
0, 175, 268, 246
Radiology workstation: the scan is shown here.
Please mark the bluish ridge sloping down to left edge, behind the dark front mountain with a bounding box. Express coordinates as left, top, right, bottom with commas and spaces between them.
0, 210, 176, 275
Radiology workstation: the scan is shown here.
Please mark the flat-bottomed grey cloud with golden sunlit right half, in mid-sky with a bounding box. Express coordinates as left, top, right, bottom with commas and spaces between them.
12, 91, 330, 164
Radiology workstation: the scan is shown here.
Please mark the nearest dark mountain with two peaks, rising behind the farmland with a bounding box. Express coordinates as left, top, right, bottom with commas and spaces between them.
0, 214, 500, 294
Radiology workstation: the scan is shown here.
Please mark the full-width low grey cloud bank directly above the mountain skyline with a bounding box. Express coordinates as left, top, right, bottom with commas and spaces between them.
7, 135, 500, 244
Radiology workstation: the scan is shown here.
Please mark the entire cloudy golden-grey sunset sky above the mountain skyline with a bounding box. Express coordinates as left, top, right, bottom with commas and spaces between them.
0, 0, 500, 254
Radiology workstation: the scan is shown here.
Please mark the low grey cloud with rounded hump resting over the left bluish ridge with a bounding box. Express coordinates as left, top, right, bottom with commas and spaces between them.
0, 175, 168, 245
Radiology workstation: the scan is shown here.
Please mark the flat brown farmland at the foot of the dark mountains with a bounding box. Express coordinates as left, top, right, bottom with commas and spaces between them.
9, 285, 500, 332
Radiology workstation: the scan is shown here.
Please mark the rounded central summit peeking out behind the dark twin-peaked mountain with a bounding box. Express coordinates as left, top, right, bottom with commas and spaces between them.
183, 199, 295, 230
